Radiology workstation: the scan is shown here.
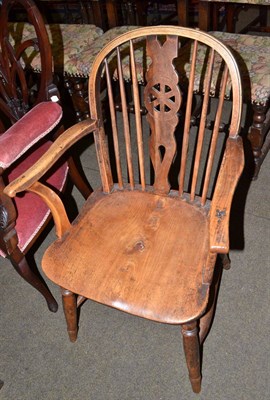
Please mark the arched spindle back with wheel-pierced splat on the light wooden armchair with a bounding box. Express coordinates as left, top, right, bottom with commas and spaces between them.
89, 26, 242, 206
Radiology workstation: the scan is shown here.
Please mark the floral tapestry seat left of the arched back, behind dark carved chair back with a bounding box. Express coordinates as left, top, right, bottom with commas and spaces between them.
9, 22, 137, 78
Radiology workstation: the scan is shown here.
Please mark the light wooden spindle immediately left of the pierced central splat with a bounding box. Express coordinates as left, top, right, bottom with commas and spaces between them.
130, 40, 145, 190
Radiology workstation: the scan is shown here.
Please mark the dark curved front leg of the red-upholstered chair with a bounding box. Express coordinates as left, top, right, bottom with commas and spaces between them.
9, 248, 58, 312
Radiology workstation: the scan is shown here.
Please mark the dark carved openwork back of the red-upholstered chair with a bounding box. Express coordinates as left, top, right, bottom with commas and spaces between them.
0, 0, 59, 130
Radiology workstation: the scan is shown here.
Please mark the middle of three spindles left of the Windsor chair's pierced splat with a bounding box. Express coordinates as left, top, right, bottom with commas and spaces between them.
117, 47, 134, 189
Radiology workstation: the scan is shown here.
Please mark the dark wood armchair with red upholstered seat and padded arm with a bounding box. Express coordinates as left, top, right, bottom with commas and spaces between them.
0, 0, 91, 311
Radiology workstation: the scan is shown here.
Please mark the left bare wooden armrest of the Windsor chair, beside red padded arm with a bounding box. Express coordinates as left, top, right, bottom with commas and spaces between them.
4, 119, 98, 197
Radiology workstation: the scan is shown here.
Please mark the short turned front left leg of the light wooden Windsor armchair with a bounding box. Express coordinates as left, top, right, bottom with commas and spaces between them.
62, 289, 78, 342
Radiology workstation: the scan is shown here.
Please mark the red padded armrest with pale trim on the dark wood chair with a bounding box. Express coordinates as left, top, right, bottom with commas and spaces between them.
0, 101, 62, 169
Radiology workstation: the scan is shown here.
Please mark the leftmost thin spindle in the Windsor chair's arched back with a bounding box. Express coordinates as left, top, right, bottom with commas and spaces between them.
104, 59, 123, 189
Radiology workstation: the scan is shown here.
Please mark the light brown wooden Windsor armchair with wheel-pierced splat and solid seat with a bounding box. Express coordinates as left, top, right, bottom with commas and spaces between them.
4, 26, 244, 392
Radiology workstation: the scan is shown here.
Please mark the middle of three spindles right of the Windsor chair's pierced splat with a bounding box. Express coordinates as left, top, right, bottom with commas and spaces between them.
190, 49, 215, 201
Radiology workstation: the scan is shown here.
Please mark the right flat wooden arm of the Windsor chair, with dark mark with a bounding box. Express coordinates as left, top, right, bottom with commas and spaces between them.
210, 136, 244, 253
